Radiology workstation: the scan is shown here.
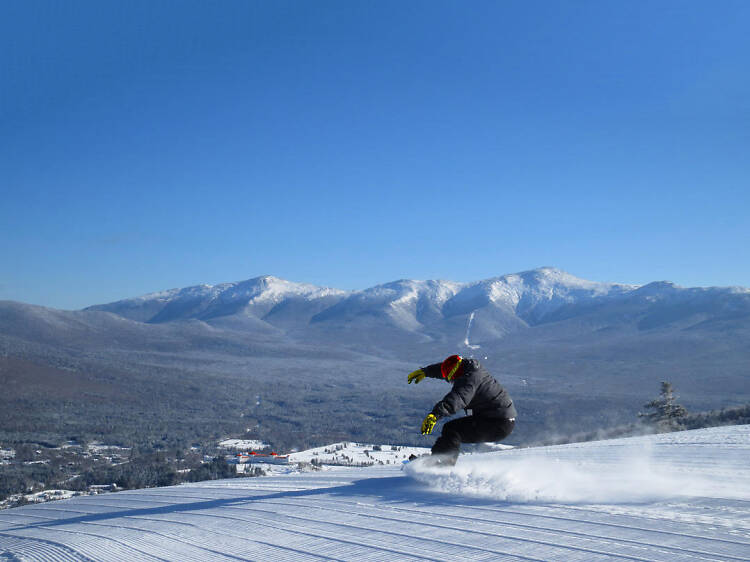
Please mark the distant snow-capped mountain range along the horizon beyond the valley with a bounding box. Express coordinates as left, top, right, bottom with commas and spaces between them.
73, 267, 750, 353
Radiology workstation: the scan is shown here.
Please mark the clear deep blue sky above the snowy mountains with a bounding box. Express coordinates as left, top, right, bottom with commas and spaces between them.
0, 0, 750, 308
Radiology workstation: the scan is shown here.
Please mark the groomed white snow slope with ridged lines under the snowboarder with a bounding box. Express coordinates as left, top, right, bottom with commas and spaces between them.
0, 426, 750, 561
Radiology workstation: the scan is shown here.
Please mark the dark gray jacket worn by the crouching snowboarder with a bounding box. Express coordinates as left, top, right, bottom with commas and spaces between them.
422, 359, 516, 419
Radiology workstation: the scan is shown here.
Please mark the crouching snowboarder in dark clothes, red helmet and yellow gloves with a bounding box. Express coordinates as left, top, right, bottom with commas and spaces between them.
408, 355, 516, 466
